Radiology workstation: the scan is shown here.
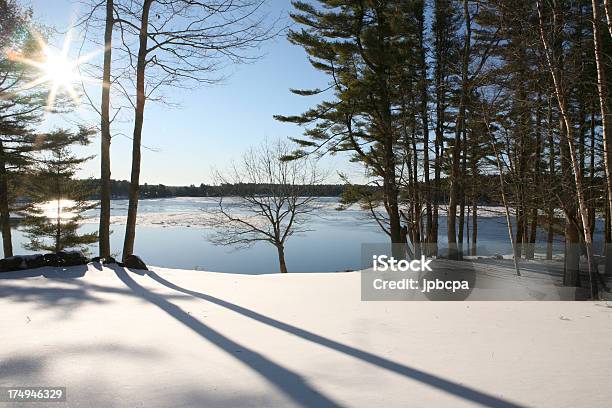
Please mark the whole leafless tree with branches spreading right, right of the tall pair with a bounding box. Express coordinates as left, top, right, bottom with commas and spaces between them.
109, 0, 275, 258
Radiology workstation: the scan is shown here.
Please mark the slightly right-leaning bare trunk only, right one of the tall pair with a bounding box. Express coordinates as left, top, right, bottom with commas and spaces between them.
123, 0, 152, 259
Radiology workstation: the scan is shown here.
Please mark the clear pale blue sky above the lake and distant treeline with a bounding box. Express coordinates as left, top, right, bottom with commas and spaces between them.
23, 0, 361, 185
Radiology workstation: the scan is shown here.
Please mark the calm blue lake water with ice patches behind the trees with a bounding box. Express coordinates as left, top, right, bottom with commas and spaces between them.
4, 198, 584, 274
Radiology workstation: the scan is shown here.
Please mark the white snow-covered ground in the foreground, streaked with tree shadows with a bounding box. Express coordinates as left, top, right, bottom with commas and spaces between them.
0, 265, 612, 408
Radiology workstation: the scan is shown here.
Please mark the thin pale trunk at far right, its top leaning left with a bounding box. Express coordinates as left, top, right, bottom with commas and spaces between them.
537, 0, 599, 299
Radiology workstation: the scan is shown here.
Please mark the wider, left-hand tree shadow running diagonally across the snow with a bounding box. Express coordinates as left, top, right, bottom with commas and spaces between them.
114, 268, 342, 407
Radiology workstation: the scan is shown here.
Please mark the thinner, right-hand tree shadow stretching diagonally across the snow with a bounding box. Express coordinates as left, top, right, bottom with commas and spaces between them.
148, 271, 523, 408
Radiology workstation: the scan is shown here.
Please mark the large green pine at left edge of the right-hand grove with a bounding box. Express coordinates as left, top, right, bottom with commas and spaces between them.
275, 0, 421, 255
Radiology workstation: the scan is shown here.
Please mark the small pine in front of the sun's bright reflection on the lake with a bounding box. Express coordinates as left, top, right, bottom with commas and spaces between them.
24, 129, 98, 252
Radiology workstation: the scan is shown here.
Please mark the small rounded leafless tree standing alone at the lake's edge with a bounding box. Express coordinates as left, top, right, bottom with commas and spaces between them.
210, 141, 324, 273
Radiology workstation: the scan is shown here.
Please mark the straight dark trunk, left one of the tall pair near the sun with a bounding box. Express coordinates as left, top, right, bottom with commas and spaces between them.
98, 0, 114, 258
